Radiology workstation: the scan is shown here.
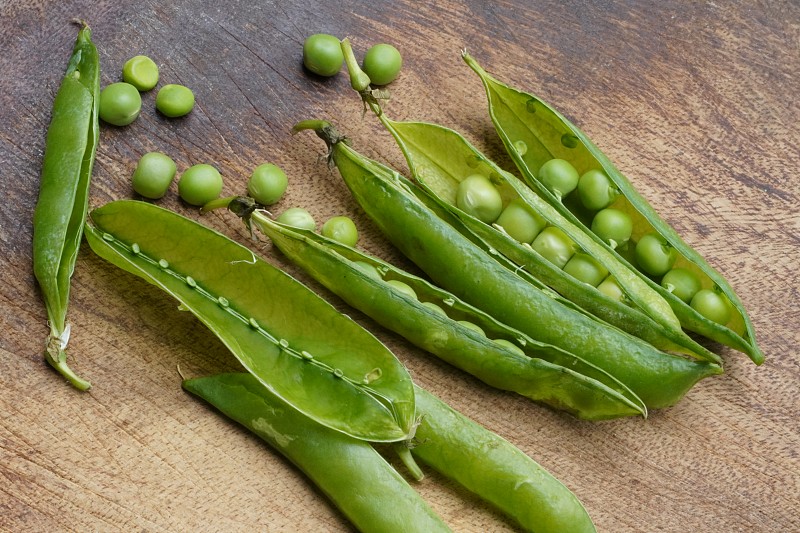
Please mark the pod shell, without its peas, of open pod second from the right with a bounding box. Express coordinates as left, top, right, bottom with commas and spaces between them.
380, 114, 721, 363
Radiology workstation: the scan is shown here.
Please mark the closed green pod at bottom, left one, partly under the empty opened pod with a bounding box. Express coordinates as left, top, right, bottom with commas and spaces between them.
183, 374, 450, 533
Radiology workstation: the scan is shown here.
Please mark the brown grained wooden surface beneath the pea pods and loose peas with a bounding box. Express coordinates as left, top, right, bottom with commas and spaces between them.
0, 0, 800, 532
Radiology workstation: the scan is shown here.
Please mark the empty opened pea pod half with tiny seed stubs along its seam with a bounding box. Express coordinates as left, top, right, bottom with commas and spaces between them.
86, 201, 414, 442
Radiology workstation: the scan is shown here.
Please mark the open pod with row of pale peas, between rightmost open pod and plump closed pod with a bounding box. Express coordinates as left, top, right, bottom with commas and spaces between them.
379, 113, 720, 362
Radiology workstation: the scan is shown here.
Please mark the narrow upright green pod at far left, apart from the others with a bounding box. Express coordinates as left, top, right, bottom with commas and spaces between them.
33, 24, 100, 390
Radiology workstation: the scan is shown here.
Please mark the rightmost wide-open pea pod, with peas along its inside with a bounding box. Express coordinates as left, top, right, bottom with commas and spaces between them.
463, 52, 764, 364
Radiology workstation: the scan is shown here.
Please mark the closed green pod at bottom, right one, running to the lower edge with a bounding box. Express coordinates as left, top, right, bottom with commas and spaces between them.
411, 387, 595, 533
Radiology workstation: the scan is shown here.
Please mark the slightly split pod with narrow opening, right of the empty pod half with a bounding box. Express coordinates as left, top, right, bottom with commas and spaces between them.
250, 211, 647, 420
